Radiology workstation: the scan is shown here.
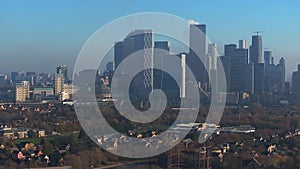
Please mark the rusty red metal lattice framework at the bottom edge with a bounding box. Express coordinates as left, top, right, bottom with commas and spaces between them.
168, 141, 212, 169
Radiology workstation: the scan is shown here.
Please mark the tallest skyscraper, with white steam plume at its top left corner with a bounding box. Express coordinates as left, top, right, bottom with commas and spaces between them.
187, 24, 208, 90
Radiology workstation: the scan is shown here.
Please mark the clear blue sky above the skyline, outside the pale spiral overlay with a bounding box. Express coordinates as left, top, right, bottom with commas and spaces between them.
0, 0, 300, 79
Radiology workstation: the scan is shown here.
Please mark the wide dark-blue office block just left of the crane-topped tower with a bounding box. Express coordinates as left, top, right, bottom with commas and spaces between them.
224, 44, 248, 92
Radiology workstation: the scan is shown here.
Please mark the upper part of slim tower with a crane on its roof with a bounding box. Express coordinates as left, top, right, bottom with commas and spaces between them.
250, 35, 263, 63
